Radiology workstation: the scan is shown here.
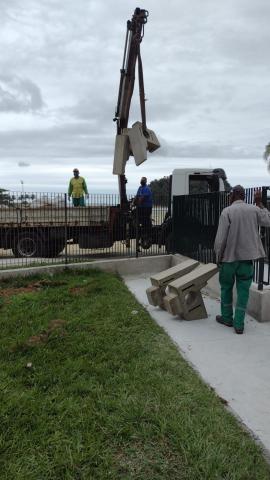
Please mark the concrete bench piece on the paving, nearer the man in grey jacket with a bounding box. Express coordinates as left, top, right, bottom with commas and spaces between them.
163, 263, 218, 320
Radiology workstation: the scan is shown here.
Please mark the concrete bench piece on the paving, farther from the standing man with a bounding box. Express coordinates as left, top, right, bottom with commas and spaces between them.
146, 259, 199, 308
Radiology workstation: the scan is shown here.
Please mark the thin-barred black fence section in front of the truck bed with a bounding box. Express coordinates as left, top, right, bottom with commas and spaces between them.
0, 192, 168, 269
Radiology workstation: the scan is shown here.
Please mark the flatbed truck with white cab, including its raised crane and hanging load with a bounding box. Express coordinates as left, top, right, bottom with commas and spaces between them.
0, 8, 226, 257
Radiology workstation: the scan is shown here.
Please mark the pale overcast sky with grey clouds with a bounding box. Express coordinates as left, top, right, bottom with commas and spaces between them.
0, 0, 270, 193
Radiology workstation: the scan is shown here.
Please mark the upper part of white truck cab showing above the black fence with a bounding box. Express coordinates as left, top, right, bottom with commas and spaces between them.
171, 168, 225, 197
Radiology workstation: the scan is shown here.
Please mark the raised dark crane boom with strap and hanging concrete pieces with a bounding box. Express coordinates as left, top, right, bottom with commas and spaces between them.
113, 8, 160, 207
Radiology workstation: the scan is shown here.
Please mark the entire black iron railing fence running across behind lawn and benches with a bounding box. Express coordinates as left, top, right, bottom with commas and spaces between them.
0, 187, 270, 289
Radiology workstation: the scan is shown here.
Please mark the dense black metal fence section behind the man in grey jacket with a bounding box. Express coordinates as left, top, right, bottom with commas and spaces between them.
172, 187, 270, 289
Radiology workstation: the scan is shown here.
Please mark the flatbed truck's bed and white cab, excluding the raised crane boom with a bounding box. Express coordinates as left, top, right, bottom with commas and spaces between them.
0, 168, 228, 257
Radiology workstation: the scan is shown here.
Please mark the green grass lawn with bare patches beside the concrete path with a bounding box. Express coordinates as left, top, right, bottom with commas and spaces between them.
0, 271, 270, 480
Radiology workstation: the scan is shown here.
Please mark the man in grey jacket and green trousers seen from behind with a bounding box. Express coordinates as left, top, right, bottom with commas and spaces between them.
214, 185, 270, 334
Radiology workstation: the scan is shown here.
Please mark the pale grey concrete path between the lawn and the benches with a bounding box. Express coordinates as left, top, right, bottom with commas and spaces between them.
124, 273, 270, 455
